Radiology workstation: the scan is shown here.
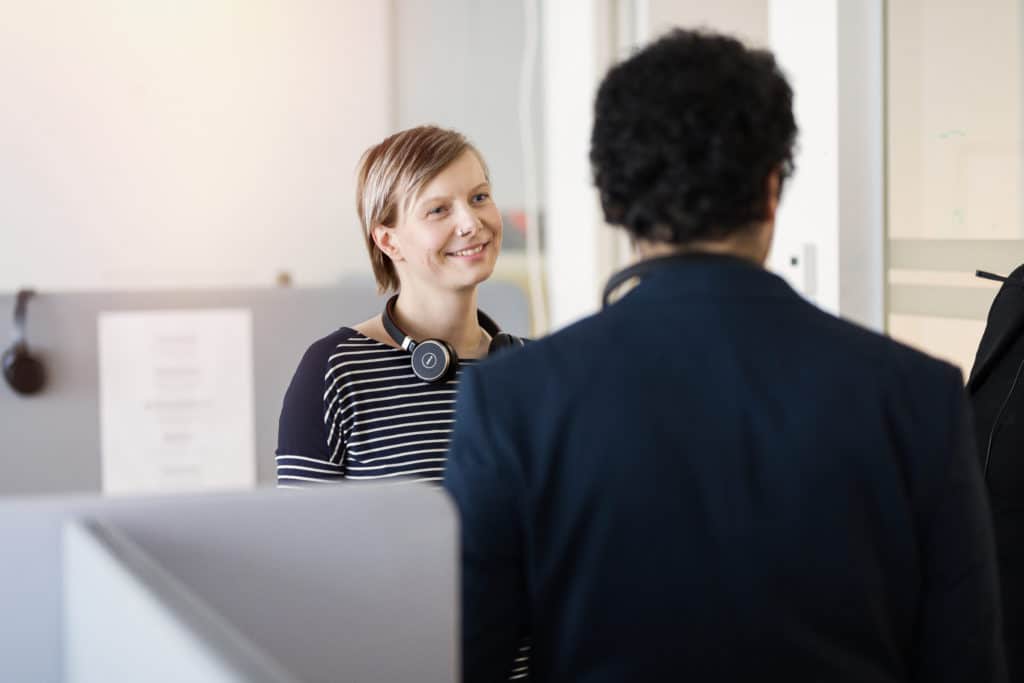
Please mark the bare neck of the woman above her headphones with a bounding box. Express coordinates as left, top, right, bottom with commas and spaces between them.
394, 288, 489, 358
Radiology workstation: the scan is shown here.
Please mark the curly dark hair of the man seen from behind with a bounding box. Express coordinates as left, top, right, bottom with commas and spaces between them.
590, 30, 797, 245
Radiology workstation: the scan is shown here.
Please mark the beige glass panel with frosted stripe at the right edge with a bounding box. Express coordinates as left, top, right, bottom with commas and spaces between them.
886, 0, 1024, 375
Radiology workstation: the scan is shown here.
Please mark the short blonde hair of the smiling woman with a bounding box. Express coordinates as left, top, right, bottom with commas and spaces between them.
355, 126, 490, 294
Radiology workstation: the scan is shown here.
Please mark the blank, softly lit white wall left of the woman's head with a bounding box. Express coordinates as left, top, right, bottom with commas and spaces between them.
0, 0, 392, 291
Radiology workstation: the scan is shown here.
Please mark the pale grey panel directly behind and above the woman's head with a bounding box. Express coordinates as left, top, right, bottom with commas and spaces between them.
392, 0, 544, 296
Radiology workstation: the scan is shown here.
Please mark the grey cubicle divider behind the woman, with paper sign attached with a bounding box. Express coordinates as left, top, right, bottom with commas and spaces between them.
0, 279, 529, 496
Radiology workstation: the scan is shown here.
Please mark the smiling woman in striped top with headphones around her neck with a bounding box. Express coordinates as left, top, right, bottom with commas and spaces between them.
276, 126, 521, 486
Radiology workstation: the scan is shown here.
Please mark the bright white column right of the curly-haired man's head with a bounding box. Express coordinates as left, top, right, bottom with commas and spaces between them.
768, 0, 884, 330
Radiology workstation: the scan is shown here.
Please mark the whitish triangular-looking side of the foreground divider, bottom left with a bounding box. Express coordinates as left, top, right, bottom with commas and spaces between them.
63, 521, 301, 683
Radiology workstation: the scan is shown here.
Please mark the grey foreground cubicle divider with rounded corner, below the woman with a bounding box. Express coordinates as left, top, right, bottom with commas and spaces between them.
0, 483, 458, 683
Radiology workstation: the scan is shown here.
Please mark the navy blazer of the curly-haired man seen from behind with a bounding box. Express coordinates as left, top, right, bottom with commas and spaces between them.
444, 257, 1006, 683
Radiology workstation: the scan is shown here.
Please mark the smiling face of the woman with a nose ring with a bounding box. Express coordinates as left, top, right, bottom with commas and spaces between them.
378, 150, 502, 290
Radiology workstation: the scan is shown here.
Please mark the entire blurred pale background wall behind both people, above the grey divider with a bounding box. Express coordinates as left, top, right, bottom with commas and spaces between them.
0, 0, 1024, 368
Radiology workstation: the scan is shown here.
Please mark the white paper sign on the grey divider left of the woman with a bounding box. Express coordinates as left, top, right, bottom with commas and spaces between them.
98, 309, 256, 494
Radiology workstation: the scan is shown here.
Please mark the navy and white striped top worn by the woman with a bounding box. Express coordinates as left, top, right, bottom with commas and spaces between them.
276, 328, 476, 487
